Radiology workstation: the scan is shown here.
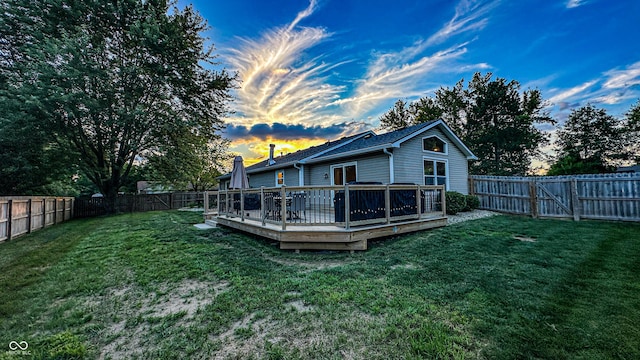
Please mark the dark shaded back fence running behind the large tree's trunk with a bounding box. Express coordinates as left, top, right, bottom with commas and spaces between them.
74, 192, 204, 218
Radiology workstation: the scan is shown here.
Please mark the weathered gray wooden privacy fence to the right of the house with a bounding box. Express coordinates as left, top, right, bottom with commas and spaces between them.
469, 174, 640, 221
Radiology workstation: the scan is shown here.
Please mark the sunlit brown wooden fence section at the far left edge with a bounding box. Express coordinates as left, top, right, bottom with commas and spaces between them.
0, 196, 75, 241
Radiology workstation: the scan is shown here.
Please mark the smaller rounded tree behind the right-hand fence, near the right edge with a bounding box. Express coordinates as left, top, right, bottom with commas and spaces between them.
557, 104, 625, 172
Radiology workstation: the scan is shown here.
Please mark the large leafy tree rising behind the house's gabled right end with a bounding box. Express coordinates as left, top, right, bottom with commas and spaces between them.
381, 73, 554, 175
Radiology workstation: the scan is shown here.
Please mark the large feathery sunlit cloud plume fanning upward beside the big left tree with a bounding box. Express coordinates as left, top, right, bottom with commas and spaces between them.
228, 1, 344, 129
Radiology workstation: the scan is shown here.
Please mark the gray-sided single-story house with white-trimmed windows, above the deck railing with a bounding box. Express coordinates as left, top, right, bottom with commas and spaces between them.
219, 120, 477, 194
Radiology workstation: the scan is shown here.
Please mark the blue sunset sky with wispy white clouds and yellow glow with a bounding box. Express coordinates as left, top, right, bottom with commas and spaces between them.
178, 0, 640, 164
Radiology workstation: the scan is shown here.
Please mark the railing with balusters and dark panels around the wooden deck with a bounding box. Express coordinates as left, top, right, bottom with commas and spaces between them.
205, 185, 446, 230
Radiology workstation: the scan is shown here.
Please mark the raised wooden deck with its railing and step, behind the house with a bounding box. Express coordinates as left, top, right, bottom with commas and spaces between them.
205, 185, 447, 251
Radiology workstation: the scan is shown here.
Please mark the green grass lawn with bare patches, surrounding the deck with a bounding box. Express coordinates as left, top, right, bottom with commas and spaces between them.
0, 212, 640, 359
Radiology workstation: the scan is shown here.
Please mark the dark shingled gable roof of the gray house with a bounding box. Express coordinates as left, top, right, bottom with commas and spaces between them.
219, 120, 477, 179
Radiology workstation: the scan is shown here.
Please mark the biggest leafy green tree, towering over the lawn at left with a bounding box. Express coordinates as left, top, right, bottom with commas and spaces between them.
0, 0, 235, 210
